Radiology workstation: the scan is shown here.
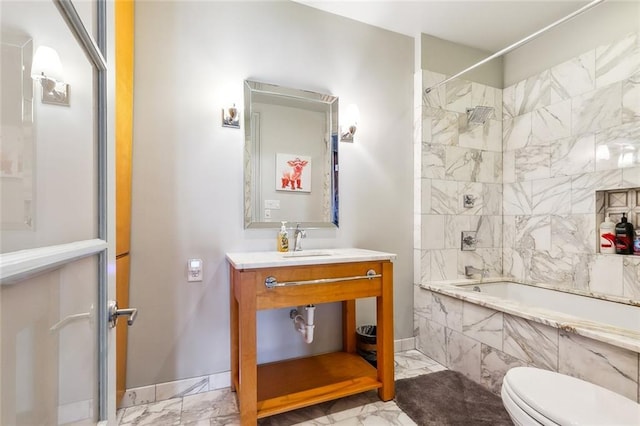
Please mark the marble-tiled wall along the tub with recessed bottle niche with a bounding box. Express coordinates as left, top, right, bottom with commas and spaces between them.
502, 34, 640, 300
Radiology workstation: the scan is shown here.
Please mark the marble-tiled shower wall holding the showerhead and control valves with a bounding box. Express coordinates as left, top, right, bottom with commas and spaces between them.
414, 71, 502, 284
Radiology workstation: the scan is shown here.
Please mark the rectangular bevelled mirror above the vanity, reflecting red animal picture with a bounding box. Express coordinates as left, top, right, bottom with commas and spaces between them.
244, 80, 338, 228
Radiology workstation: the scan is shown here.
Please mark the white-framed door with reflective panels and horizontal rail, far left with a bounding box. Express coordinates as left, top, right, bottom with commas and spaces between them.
0, 0, 115, 425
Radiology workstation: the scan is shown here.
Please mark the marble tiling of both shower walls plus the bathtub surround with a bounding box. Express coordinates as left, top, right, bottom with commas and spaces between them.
414, 34, 640, 401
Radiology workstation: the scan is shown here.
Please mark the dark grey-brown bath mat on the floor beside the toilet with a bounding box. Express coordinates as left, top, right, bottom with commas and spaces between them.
395, 370, 513, 426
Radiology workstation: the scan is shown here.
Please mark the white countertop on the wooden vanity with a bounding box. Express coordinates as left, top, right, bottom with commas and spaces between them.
226, 248, 396, 269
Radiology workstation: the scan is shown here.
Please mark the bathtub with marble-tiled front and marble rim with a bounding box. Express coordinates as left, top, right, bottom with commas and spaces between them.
414, 278, 640, 402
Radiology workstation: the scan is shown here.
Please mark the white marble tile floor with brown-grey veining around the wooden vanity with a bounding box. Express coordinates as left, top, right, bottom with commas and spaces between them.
117, 350, 446, 426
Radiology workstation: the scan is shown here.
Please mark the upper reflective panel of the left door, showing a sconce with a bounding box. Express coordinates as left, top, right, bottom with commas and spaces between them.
0, 1, 99, 253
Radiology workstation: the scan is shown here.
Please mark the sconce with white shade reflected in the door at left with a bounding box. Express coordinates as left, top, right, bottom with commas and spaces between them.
31, 46, 69, 106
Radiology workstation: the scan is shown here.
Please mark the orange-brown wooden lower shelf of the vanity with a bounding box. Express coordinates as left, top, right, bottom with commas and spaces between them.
257, 352, 382, 418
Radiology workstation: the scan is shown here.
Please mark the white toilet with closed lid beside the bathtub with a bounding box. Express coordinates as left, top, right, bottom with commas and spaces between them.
501, 367, 640, 426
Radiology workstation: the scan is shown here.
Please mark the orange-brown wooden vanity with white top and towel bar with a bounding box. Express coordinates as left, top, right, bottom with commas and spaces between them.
227, 249, 395, 425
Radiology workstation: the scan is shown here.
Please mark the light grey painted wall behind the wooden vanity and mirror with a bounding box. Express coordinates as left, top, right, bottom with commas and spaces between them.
127, 1, 414, 388
